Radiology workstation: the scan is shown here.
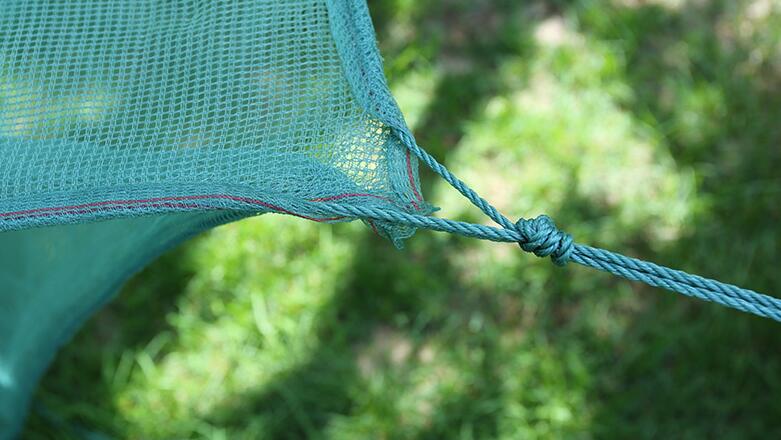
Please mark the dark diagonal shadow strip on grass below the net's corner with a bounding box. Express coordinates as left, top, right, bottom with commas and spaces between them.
201, 234, 464, 438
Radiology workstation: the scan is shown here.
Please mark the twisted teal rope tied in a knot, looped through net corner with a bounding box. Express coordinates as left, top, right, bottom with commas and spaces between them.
312, 132, 781, 322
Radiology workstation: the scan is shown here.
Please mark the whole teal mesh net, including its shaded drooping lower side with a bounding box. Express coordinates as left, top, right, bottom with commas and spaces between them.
0, 0, 430, 437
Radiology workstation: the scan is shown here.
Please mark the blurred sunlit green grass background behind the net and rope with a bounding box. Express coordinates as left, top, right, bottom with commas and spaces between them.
25, 0, 781, 439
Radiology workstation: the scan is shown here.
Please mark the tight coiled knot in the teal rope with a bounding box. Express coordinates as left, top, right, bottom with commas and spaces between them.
515, 215, 573, 266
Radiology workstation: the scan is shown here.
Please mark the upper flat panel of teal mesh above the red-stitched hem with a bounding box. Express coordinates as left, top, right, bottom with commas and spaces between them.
0, 0, 424, 237
